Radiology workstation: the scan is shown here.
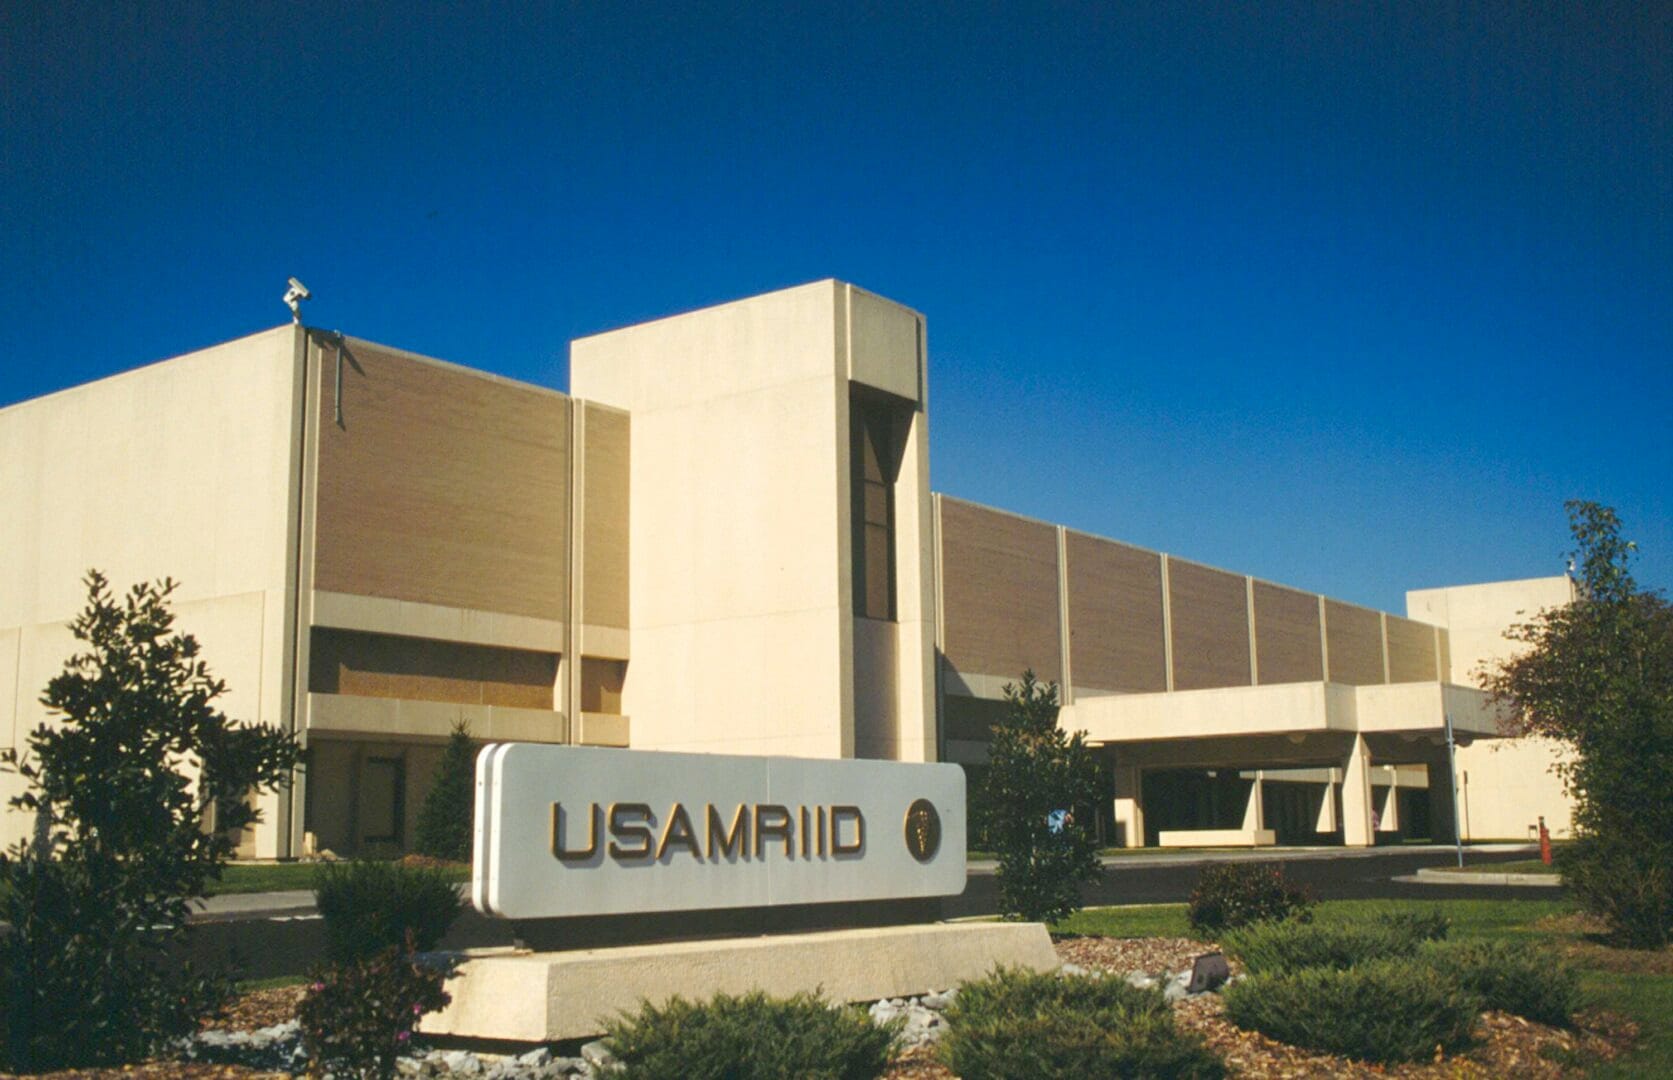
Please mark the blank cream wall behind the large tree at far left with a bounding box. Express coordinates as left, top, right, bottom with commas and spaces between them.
0, 334, 299, 854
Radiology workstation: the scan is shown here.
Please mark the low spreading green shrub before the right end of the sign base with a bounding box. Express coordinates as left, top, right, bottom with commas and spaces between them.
939, 970, 1225, 1080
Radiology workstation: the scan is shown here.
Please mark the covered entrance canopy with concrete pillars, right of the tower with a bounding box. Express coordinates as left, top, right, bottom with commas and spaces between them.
1059, 682, 1499, 848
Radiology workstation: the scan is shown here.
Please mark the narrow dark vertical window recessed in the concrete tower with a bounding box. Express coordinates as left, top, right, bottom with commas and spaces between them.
848, 391, 900, 619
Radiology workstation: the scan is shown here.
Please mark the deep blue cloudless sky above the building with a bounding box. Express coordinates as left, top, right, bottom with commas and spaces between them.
0, 0, 1673, 610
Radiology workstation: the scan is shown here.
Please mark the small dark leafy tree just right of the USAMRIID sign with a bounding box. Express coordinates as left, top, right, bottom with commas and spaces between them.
975, 670, 1099, 921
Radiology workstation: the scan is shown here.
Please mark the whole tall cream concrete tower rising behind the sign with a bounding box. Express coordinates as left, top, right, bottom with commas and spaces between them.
570, 281, 935, 761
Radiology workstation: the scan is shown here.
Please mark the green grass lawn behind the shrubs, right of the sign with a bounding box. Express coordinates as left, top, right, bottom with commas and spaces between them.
1052, 899, 1673, 1080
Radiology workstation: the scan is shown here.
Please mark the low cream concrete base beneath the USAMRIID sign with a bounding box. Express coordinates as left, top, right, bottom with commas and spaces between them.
420, 923, 1057, 1043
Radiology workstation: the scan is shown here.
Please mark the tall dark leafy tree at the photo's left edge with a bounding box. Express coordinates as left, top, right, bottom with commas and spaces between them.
0, 570, 298, 1070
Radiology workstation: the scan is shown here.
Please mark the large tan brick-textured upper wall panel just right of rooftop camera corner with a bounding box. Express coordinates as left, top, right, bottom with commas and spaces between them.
313, 336, 569, 620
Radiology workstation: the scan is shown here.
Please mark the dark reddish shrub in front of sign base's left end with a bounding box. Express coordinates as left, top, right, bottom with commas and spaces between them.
296, 946, 452, 1080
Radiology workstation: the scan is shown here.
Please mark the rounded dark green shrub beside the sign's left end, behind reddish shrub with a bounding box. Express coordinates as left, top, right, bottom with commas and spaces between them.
315, 861, 460, 963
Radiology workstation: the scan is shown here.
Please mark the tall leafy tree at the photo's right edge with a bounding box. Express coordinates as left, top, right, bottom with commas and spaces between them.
1489, 502, 1673, 946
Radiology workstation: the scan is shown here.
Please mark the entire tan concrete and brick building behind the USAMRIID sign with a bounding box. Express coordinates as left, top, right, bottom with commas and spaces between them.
0, 281, 1566, 858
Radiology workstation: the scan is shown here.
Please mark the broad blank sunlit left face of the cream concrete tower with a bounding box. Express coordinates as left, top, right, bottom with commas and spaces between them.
570, 281, 855, 757
